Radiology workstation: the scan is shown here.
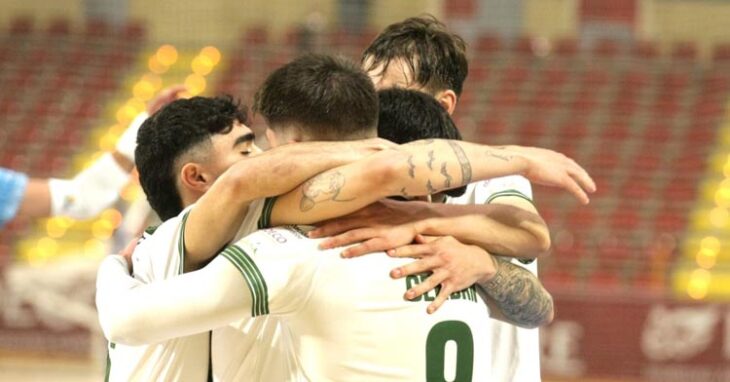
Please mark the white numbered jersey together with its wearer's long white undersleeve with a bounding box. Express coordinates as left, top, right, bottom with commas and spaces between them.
98, 227, 491, 381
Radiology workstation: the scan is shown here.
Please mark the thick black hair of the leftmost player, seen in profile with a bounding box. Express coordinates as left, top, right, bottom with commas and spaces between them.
134, 96, 247, 221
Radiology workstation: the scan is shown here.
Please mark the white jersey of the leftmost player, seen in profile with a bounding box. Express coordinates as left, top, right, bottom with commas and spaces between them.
107, 200, 266, 381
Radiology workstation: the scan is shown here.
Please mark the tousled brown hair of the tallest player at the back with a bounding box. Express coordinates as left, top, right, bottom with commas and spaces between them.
362, 15, 469, 96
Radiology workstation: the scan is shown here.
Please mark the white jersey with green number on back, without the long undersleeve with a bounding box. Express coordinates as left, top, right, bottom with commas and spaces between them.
222, 227, 492, 381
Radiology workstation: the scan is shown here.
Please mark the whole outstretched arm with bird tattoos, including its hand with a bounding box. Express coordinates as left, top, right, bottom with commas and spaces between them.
271, 140, 595, 225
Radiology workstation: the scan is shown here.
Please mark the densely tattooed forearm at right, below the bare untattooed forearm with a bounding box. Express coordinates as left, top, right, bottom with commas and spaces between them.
478, 257, 554, 328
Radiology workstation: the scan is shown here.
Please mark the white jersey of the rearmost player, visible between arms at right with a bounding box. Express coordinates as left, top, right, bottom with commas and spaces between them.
447, 175, 540, 382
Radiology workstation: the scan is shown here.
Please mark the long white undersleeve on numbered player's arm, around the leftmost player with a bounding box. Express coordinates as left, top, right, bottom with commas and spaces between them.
96, 256, 250, 345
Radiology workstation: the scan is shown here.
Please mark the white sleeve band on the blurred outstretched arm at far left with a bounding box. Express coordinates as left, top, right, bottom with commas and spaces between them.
48, 153, 129, 219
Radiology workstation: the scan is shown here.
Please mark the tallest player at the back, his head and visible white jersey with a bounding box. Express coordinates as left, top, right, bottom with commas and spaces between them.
362, 16, 540, 380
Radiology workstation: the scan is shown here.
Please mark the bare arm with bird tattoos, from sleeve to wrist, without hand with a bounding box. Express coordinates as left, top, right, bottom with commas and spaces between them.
274, 140, 526, 224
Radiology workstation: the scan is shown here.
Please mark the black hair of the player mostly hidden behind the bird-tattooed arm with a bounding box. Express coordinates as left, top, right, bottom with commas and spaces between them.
378, 88, 466, 197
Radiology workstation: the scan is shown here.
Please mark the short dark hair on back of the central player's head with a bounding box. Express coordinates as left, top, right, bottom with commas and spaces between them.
253, 54, 378, 140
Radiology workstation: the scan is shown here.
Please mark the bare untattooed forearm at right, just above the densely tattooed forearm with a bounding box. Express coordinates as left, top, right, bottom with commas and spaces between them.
415, 204, 550, 258
